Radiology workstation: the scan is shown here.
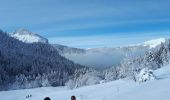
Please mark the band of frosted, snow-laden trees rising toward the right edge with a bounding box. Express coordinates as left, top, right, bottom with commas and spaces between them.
66, 39, 170, 88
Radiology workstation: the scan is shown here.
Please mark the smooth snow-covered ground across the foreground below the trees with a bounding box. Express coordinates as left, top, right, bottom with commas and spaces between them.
0, 65, 170, 100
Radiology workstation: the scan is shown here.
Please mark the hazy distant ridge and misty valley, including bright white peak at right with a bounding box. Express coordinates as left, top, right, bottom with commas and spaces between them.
53, 38, 166, 68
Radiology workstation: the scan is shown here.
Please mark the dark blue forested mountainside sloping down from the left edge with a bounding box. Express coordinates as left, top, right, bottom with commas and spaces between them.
0, 31, 88, 90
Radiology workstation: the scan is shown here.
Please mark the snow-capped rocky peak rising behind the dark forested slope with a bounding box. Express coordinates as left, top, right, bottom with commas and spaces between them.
10, 29, 48, 43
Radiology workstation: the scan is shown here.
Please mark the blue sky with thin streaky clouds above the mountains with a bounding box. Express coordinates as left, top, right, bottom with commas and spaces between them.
0, 0, 170, 48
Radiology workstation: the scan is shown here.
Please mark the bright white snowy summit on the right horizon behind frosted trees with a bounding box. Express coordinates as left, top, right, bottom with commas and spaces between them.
143, 38, 166, 48
